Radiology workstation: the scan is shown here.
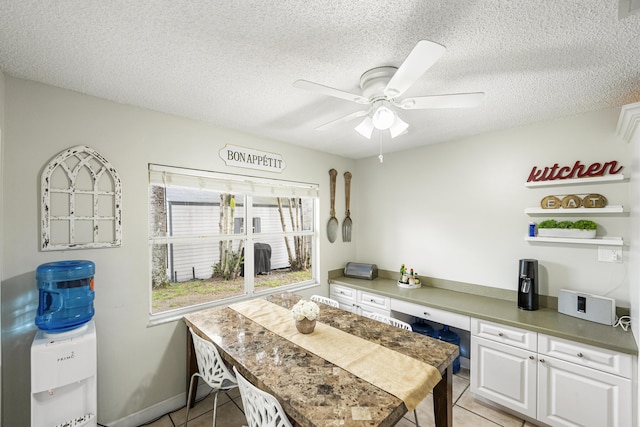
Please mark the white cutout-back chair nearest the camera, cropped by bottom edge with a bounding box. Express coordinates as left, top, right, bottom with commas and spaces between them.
233, 366, 293, 427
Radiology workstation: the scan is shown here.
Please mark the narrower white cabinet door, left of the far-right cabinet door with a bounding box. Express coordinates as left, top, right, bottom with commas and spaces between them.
471, 335, 537, 418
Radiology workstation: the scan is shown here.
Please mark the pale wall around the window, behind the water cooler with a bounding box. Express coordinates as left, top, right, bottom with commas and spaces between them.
0, 77, 355, 426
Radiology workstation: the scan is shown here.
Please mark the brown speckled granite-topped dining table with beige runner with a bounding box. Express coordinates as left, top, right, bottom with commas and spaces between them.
184, 293, 458, 427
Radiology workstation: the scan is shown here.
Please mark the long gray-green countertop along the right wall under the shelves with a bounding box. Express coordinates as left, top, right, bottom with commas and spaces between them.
330, 276, 638, 355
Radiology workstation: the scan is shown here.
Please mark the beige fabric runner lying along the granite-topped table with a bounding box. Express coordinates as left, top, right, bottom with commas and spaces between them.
229, 299, 442, 411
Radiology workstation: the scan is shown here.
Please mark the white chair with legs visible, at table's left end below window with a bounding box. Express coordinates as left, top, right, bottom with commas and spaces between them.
184, 328, 238, 427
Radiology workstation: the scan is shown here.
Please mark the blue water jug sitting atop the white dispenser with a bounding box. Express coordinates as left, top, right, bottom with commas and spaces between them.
36, 261, 96, 333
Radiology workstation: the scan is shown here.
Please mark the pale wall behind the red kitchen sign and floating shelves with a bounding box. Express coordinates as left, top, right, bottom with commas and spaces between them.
351, 109, 631, 307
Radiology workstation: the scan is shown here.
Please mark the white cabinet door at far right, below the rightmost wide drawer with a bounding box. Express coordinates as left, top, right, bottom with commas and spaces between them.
538, 355, 632, 427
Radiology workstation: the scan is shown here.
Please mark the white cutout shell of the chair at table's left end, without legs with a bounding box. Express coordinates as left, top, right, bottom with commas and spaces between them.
189, 328, 238, 390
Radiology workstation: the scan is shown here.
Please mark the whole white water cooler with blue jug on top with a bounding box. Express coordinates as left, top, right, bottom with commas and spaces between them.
31, 261, 97, 427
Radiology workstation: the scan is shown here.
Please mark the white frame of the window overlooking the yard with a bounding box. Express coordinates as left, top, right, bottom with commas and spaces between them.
147, 163, 320, 326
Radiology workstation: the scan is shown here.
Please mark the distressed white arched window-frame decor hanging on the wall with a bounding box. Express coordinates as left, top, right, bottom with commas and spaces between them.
40, 145, 122, 251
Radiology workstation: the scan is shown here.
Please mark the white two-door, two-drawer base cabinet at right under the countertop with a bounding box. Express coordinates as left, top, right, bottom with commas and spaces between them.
471, 319, 633, 427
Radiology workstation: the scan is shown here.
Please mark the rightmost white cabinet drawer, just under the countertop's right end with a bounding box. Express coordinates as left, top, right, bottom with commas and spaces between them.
538, 334, 633, 378
